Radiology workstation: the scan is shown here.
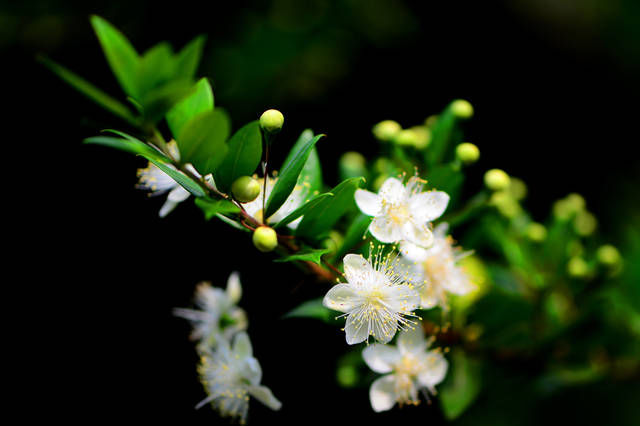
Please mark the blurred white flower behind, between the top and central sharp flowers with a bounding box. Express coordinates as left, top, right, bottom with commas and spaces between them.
400, 223, 475, 310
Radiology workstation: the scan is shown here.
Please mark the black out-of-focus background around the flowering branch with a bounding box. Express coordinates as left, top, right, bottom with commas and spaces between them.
6, 0, 640, 424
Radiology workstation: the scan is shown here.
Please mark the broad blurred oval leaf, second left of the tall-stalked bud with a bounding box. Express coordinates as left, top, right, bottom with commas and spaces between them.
177, 108, 231, 175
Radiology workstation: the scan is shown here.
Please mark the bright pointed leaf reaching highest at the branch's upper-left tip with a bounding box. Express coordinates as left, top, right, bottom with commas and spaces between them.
91, 15, 140, 98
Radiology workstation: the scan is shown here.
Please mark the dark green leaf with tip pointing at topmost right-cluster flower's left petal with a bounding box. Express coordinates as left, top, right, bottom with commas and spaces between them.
296, 177, 364, 239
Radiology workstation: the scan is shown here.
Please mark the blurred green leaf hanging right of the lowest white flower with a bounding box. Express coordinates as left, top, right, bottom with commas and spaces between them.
439, 349, 481, 420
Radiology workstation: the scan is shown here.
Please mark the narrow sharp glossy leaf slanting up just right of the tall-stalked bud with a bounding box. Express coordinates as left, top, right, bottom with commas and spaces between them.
265, 135, 324, 217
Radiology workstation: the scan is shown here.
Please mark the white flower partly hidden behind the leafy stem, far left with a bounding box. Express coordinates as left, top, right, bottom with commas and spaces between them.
137, 141, 195, 217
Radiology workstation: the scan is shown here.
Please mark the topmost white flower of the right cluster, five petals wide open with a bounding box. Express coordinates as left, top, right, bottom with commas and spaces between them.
355, 176, 449, 247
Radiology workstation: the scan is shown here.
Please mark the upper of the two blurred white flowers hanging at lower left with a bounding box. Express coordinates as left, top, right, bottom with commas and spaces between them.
173, 272, 248, 349
